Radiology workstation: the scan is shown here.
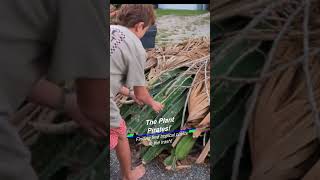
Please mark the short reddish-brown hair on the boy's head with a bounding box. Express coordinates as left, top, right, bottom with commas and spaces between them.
116, 4, 156, 28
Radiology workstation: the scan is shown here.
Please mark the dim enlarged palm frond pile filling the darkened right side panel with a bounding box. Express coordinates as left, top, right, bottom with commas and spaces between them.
211, 0, 320, 180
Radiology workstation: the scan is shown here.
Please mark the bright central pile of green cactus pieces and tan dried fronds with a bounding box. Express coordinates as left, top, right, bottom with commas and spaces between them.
116, 37, 210, 169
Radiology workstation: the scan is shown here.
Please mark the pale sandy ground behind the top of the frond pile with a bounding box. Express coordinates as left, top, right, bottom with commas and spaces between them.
156, 13, 210, 45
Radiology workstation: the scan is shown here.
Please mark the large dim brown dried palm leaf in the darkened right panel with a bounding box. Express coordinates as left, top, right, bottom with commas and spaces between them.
249, 40, 320, 180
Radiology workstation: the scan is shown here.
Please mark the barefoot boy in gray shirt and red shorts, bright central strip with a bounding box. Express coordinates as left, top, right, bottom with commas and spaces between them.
110, 4, 163, 180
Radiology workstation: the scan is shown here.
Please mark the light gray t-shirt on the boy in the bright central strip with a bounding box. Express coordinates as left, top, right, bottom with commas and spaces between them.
110, 25, 147, 128
